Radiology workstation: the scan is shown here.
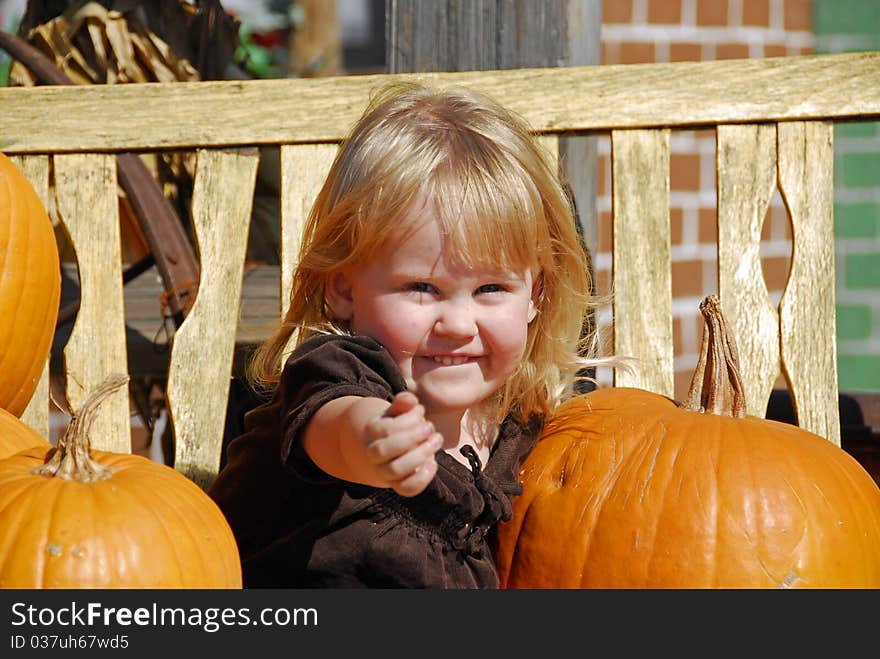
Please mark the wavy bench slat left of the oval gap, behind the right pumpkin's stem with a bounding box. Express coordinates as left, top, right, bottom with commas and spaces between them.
716, 124, 779, 417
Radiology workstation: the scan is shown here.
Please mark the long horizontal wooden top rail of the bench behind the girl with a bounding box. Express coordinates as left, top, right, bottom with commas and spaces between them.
0, 52, 880, 154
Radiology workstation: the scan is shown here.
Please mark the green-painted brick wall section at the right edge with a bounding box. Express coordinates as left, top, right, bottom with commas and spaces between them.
813, 0, 880, 393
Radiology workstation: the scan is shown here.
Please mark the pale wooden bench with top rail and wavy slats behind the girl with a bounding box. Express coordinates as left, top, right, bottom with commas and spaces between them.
6, 53, 880, 486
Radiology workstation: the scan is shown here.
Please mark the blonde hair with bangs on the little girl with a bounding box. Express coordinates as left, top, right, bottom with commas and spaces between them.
249, 83, 599, 420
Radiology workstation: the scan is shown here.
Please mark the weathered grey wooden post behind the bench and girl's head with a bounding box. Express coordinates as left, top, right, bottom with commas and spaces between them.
385, 0, 602, 254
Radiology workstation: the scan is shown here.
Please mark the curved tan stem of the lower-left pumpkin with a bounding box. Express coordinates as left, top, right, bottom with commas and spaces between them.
33, 373, 128, 483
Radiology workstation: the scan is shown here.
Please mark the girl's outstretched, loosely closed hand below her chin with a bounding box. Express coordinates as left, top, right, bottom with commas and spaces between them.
364, 391, 443, 497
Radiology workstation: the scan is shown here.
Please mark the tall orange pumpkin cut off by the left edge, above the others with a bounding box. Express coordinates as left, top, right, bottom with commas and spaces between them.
0, 153, 61, 416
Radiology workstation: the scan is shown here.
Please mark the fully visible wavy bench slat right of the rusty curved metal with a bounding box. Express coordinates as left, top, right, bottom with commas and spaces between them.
167, 149, 259, 487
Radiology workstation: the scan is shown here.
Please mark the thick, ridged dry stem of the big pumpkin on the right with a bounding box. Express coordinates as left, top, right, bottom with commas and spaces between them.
683, 295, 746, 418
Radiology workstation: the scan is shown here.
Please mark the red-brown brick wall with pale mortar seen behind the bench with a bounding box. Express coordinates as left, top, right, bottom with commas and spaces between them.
596, 0, 816, 398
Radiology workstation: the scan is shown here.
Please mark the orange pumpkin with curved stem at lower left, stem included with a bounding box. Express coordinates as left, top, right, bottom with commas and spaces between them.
0, 378, 241, 588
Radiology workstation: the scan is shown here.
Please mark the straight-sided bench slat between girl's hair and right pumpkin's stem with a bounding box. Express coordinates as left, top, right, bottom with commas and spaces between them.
611, 130, 675, 397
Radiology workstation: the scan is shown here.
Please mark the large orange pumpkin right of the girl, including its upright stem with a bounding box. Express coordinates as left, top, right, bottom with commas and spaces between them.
495, 296, 880, 588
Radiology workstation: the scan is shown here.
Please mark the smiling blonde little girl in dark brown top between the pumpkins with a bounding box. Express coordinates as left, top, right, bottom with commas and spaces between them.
210, 84, 596, 588
